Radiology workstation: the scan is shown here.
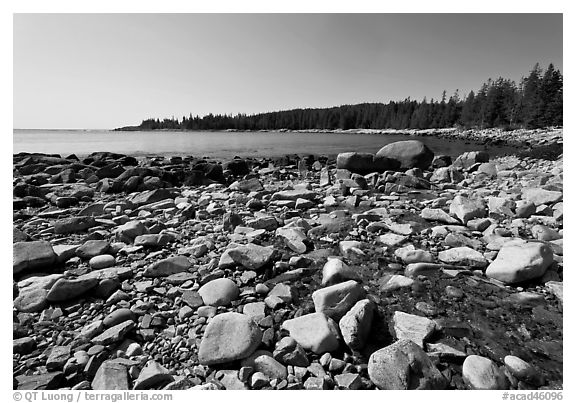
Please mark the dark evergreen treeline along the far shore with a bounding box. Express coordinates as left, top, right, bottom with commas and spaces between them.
121, 64, 563, 130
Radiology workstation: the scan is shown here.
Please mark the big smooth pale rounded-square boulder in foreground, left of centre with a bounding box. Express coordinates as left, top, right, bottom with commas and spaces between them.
198, 312, 262, 365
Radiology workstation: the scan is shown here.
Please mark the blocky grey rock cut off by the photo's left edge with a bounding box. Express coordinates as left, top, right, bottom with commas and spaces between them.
12, 241, 56, 274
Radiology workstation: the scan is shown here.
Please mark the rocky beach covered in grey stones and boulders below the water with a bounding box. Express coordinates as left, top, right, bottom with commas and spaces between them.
13, 129, 563, 390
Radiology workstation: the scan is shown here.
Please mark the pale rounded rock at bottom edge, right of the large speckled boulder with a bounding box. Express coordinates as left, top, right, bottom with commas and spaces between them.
462, 355, 508, 390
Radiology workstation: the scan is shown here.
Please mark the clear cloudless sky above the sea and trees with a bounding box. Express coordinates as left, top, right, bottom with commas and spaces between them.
13, 14, 563, 129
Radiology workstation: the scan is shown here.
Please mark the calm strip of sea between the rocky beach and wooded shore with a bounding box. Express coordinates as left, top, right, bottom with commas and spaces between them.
12, 129, 514, 159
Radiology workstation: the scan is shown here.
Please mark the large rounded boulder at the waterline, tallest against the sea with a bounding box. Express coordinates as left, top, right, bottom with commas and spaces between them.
375, 140, 434, 170
